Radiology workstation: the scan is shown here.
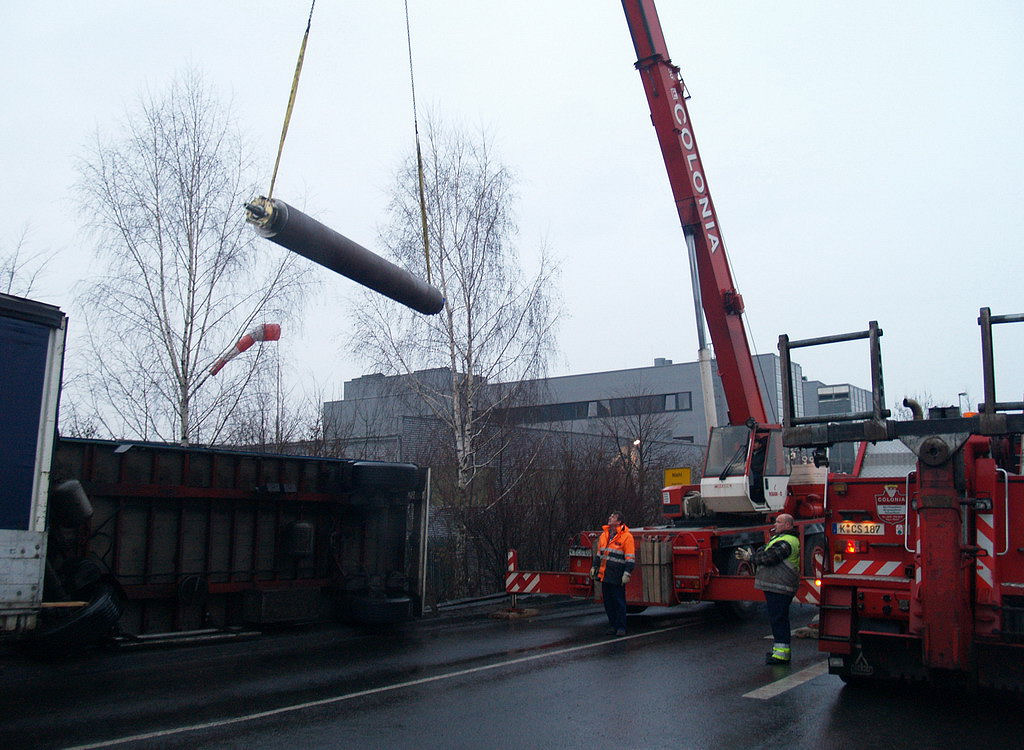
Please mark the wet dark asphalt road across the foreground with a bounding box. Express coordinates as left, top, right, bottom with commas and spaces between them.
0, 605, 1024, 750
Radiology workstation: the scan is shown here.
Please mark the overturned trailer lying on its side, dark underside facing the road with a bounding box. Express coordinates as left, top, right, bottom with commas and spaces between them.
43, 439, 428, 640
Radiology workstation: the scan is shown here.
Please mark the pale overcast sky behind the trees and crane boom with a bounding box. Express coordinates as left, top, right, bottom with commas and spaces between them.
8, 0, 1024, 413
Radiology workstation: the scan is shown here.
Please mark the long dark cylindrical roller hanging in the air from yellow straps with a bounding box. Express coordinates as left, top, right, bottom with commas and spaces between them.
246, 196, 444, 316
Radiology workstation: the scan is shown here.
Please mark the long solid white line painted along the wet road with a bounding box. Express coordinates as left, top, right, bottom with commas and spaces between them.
67, 623, 693, 750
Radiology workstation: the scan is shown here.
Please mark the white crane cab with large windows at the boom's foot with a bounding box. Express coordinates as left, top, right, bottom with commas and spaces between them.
700, 424, 790, 513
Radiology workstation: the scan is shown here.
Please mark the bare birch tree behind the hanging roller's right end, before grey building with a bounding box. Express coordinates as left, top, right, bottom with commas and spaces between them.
353, 121, 557, 499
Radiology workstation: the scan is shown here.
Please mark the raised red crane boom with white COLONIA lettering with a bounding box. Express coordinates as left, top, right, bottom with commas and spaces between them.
623, 0, 768, 424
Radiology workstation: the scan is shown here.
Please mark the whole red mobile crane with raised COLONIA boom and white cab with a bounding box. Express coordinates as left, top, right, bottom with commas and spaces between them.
506, 0, 825, 612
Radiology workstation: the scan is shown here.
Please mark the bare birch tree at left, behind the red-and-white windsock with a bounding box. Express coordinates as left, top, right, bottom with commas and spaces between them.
77, 72, 303, 443
